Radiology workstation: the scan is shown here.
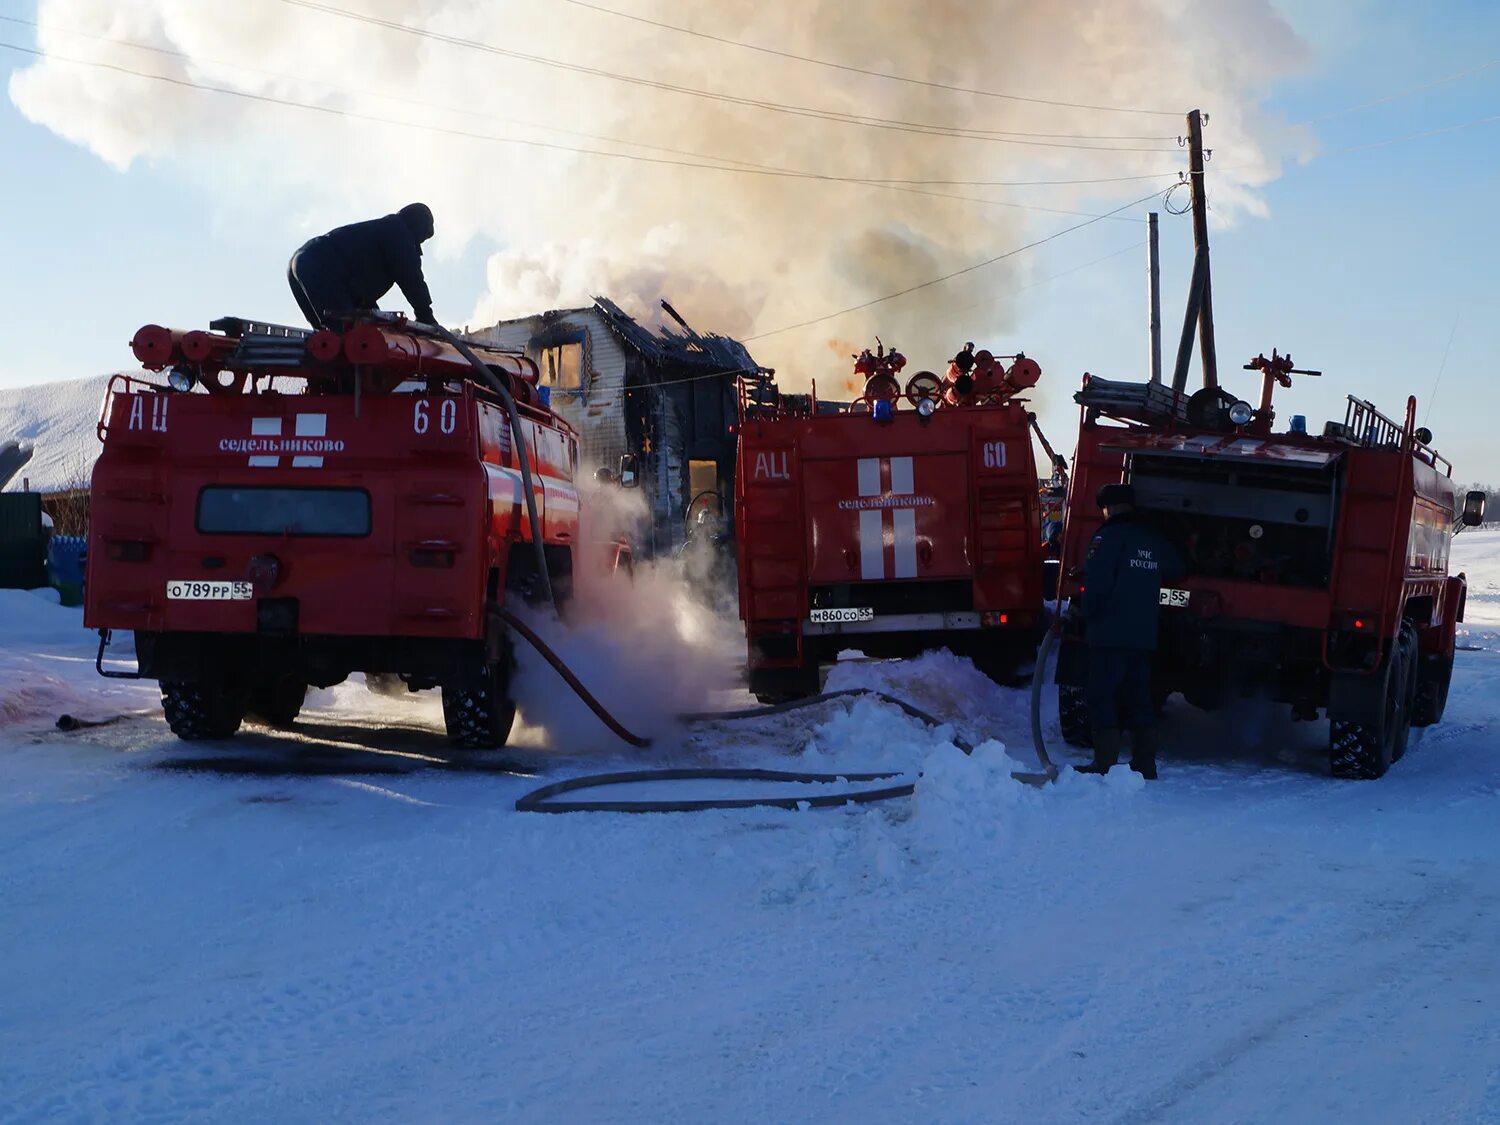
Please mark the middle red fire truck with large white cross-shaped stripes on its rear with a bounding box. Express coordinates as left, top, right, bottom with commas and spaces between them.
735, 345, 1044, 702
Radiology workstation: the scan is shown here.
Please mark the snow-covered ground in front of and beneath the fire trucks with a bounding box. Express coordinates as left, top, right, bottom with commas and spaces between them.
0, 543, 1500, 1122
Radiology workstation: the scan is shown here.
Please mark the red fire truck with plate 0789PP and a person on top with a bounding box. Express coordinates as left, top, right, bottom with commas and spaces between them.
84, 314, 579, 747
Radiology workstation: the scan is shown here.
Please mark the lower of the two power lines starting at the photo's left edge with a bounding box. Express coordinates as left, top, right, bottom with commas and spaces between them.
0, 42, 1160, 218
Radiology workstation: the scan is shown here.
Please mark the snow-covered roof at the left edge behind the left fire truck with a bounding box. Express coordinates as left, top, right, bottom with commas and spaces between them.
0, 375, 110, 492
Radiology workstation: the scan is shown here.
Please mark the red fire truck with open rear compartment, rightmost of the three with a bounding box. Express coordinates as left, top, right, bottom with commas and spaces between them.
1058, 353, 1484, 777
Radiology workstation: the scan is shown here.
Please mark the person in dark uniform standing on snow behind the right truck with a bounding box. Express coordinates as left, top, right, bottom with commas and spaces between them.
1079, 485, 1182, 780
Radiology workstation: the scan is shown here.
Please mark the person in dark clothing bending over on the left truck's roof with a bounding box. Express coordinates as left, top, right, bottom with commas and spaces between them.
287, 203, 437, 329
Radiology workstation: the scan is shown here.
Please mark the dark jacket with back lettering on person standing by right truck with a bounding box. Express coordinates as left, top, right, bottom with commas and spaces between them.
1083, 512, 1182, 651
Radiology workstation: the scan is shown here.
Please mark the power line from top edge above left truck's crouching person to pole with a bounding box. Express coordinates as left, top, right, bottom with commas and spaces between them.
281, 0, 1172, 153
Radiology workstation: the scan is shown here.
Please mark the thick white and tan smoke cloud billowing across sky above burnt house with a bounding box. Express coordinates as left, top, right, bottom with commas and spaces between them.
11, 0, 1307, 386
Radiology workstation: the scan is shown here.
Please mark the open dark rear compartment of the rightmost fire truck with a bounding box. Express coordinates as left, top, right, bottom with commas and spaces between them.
1130, 455, 1338, 590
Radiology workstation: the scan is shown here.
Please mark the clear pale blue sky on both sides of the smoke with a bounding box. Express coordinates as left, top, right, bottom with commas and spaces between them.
0, 0, 1500, 482
